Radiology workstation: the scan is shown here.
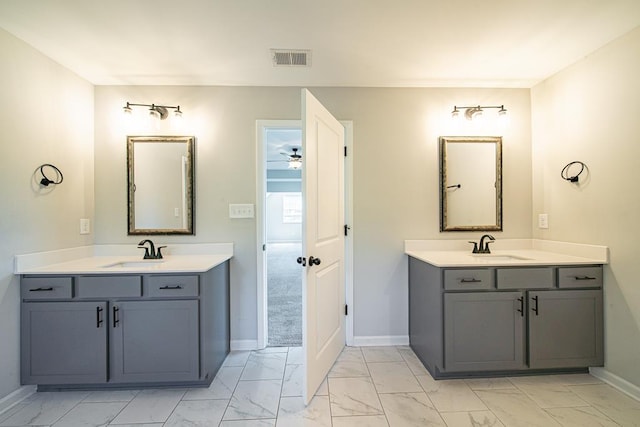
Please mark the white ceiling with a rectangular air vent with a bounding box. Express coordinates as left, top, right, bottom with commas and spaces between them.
0, 0, 640, 87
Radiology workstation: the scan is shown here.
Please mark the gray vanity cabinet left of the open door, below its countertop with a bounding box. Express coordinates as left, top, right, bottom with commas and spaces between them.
21, 261, 230, 390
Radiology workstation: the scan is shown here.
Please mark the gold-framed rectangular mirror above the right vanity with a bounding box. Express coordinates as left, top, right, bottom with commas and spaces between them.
439, 136, 502, 231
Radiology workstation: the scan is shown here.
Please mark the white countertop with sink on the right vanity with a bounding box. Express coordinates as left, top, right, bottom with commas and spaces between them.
405, 240, 608, 267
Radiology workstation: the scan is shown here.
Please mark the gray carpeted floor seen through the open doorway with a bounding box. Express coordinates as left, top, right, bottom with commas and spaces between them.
267, 243, 304, 347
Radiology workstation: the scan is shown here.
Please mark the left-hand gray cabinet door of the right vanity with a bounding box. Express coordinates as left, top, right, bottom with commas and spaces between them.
444, 292, 525, 372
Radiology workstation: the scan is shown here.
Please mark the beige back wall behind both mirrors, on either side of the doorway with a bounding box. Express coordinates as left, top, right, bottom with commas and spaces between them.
95, 86, 531, 340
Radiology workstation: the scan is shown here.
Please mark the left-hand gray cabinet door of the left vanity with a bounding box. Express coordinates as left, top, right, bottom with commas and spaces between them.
21, 302, 107, 384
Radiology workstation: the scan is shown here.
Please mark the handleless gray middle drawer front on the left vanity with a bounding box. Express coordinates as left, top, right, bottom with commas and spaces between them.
76, 275, 142, 298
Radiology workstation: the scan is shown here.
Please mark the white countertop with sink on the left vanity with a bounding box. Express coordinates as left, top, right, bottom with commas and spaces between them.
14, 244, 233, 275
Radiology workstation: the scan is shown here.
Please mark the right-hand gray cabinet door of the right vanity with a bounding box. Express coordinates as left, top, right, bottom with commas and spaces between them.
529, 290, 604, 368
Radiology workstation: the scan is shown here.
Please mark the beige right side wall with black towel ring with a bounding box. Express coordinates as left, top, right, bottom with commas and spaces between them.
532, 28, 640, 386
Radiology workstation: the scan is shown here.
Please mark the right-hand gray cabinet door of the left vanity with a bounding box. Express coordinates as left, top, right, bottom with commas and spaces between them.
110, 300, 200, 382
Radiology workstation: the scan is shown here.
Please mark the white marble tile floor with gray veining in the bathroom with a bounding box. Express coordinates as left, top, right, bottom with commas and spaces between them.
0, 347, 640, 427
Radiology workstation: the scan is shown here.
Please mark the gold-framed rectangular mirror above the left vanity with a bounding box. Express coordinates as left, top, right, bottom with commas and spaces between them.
127, 136, 195, 235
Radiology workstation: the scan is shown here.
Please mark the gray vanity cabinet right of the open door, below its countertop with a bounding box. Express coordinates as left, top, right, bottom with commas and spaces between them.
409, 257, 604, 378
